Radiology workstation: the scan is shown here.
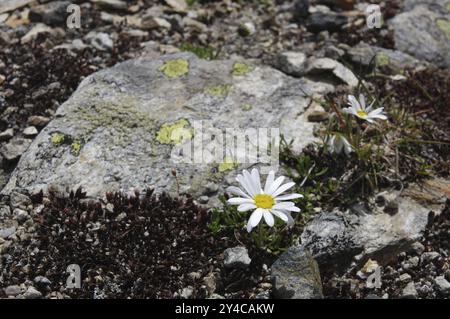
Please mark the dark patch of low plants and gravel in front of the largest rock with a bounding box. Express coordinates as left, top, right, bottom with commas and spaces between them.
0, 190, 274, 299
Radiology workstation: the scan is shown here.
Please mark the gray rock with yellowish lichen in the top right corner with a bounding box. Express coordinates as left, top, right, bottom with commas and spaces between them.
391, 0, 450, 67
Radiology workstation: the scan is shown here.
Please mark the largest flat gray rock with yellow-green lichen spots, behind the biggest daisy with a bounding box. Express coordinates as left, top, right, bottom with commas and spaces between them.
2, 53, 333, 201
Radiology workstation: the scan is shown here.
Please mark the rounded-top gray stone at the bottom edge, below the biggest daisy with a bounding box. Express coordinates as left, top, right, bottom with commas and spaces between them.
271, 246, 323, 299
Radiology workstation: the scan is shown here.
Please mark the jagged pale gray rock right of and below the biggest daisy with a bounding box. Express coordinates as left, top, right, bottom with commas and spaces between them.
301, 197, 430, 270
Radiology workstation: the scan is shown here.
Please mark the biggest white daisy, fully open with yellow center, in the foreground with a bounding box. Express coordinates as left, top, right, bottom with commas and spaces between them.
227, 168, 303, 232
